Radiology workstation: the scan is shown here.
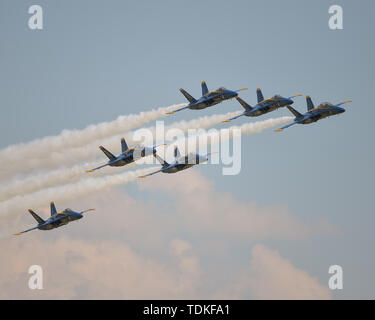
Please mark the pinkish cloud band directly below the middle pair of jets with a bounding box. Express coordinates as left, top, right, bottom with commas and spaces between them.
139, 169, 336, 239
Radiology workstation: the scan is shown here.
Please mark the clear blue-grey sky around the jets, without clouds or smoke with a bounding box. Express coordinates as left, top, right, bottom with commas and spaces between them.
0, 0, 375, 298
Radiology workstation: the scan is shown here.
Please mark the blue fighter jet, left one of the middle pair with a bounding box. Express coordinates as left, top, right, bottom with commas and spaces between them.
86, 138, 165, 172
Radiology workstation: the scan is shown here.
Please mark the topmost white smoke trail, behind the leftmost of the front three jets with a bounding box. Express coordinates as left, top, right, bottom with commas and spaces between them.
0, 103, 186, 177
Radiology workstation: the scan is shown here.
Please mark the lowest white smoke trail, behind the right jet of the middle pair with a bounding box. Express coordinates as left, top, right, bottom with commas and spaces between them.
0, 167, 159, 222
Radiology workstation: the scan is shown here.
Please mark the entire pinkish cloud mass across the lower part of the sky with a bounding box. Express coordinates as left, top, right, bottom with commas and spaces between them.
0, 169, 331, 299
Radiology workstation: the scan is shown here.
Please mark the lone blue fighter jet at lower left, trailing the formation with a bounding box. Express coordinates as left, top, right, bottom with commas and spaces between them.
15, 202, 95, 236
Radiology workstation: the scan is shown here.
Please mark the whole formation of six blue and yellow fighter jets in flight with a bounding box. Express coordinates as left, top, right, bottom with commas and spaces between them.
16, 81, 351, 235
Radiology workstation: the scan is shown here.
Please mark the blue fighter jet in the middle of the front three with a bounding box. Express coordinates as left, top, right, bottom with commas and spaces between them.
223, 88, 301, 122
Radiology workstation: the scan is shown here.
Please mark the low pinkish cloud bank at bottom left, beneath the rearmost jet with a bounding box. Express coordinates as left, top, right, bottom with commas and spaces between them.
0, 237, 200, 299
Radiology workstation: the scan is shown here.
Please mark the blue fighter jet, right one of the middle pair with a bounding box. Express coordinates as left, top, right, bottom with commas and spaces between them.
139, 147, 214, 178
